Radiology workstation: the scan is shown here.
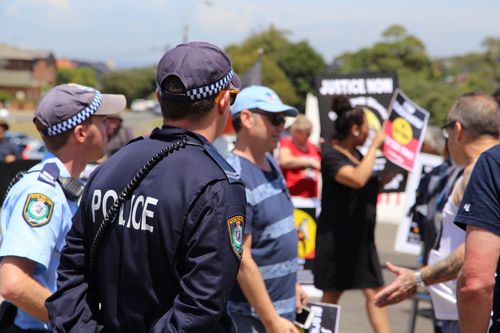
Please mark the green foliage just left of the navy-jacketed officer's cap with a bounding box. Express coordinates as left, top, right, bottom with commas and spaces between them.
102, 67, 156, 105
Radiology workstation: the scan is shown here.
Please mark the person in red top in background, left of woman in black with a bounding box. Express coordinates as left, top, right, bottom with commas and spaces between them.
278, 115, 321, 198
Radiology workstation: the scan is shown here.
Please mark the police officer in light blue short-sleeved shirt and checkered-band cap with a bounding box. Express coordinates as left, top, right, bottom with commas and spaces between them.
0, 84, 126, 332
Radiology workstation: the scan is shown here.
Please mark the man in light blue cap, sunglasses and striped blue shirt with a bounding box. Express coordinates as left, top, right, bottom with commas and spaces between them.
228, 86, 307, 333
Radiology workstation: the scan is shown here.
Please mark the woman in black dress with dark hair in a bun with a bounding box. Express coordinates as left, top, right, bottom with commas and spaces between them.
314, 96, 390, 332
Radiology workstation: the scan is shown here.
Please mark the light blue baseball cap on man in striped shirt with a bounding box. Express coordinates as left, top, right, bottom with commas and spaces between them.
231, 86, 299, 117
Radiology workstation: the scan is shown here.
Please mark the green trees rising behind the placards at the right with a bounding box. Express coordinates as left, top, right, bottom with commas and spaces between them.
334, 25, 500, 126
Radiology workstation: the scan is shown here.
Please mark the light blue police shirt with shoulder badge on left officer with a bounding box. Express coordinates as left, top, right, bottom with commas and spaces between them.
0, 152, 78, 330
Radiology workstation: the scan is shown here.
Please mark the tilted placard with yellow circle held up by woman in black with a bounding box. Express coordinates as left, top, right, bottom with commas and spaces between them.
384, 89, 429, 171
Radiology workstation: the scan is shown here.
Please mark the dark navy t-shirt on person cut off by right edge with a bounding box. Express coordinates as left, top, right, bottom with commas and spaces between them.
455, 145, 500, 328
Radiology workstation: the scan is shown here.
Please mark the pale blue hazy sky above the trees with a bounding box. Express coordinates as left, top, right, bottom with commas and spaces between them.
0, 0, 500, 67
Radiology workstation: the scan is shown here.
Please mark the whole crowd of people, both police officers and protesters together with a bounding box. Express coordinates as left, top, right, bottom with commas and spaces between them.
0, 42, 500, 333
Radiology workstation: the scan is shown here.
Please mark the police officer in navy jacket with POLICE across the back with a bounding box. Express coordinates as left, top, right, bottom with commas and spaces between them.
46, 42, 246, 333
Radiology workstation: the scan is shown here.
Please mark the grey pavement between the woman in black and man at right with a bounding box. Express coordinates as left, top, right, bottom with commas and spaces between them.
326, 223, 433, 333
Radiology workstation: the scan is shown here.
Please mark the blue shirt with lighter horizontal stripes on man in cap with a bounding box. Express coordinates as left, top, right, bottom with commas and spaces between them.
227, 154, 298, 320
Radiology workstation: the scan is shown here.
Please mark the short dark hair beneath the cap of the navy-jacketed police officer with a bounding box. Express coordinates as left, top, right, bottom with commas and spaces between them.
160, 75, 217, 120
